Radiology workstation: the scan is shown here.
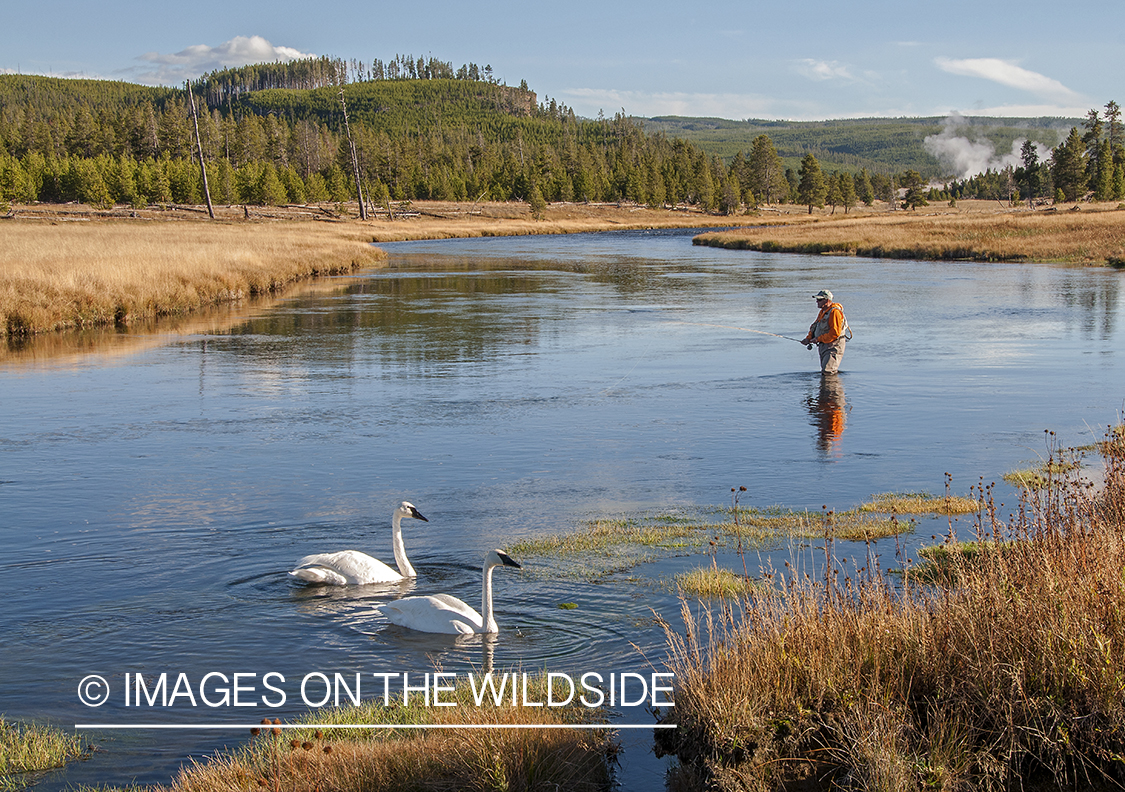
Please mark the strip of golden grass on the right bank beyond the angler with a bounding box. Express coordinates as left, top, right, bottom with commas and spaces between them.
696, 205, 1125, 264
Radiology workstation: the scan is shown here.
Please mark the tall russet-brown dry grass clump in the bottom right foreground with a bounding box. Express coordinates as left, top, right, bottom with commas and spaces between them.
659, 433, 1125, 791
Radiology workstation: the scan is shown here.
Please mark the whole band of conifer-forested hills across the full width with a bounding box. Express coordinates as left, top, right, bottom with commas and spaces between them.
0, 55, 1125, 214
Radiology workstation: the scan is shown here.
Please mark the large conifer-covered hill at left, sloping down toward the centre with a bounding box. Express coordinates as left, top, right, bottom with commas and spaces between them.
0, 57, 738, 209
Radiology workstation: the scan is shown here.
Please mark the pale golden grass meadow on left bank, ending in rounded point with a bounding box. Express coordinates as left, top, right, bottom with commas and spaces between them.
0, 222, 384, 335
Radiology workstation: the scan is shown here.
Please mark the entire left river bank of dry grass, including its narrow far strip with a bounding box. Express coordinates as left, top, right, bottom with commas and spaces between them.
0, 201, 749, 336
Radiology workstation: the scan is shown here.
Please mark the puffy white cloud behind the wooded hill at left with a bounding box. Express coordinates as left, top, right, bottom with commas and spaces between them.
122, 36, 315, 86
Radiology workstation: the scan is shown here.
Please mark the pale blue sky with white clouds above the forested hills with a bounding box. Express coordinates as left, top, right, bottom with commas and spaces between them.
0, 0, 1125, 120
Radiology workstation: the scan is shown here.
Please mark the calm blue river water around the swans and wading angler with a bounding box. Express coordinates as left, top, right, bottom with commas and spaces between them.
0, 232, 1125, 789
